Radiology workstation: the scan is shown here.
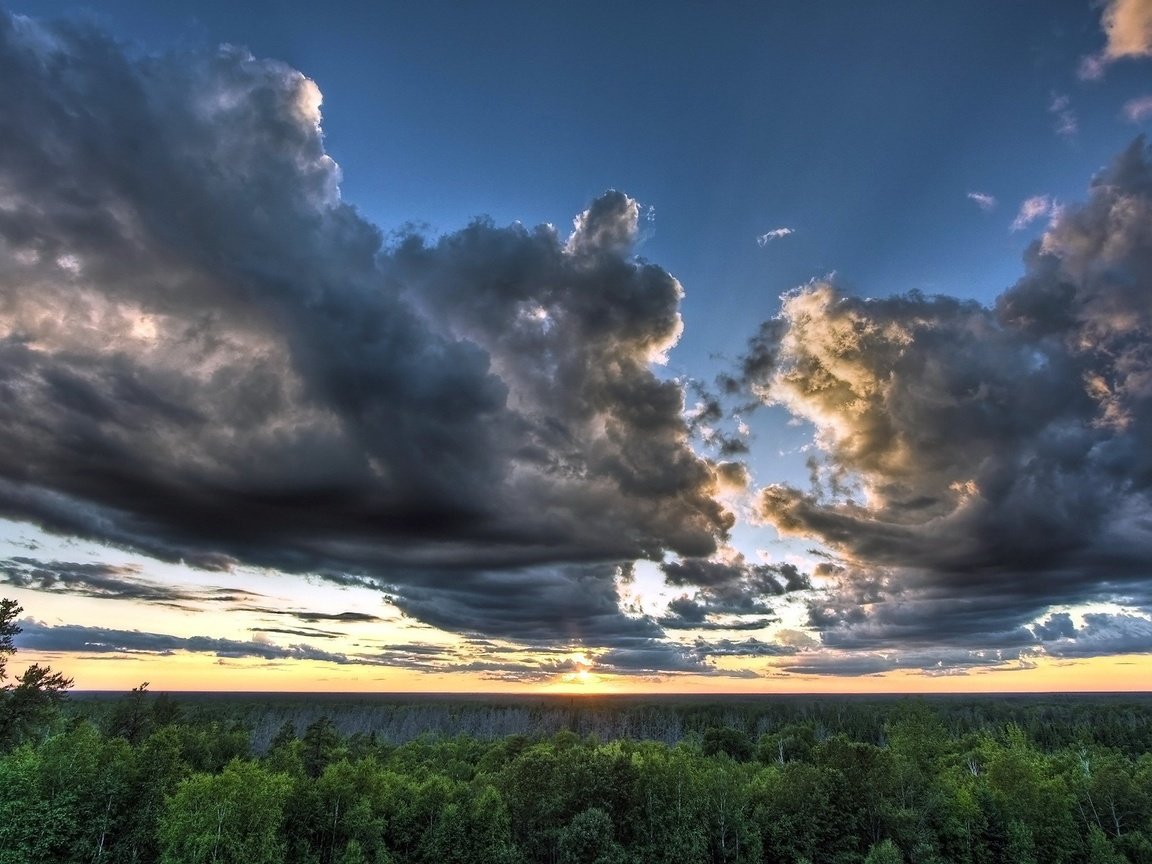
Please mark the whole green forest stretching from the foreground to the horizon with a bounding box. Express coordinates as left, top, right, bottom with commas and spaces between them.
0, 605, 1152, 864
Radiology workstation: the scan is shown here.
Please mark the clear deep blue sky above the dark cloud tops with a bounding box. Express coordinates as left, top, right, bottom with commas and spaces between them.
15, 0, 1152, 499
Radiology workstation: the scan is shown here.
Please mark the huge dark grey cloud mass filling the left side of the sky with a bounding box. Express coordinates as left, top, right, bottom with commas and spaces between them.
0, 14, 733, 663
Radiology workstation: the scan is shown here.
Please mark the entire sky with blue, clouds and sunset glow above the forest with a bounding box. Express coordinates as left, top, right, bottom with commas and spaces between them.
0, 0, 1152, 694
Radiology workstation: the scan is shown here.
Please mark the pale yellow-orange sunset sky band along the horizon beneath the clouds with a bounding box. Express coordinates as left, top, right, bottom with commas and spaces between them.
5, 564, 1152, 696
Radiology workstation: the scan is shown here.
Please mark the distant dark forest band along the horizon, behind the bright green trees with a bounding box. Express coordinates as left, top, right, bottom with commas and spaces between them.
71, 692, 1152, 753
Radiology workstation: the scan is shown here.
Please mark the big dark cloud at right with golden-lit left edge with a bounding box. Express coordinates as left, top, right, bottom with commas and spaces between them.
733, 139, 1152, 647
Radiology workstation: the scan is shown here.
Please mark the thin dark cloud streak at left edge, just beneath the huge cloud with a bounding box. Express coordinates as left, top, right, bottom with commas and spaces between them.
0, 555, 259, 607
